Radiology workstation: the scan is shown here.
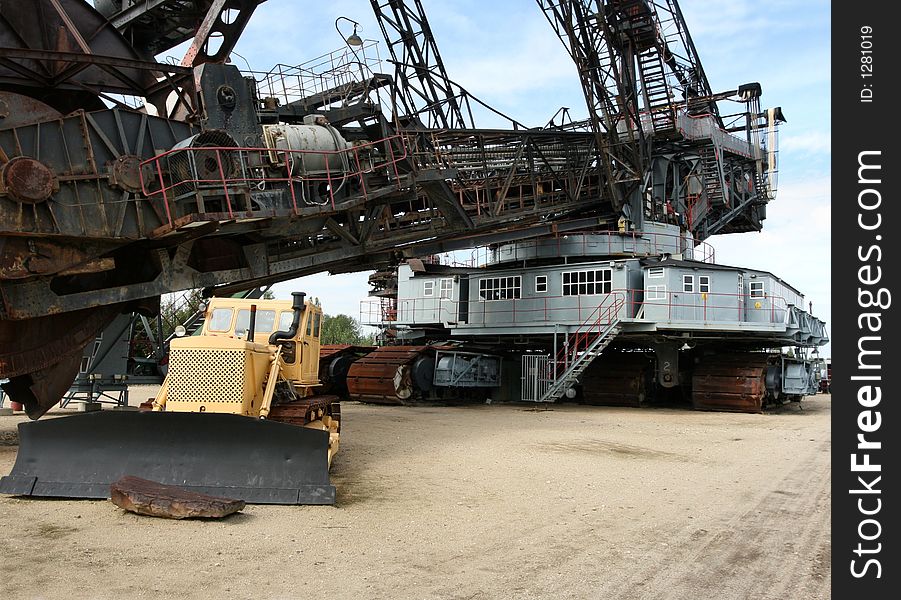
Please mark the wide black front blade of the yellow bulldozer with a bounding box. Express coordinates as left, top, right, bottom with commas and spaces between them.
0, 411, 335, 504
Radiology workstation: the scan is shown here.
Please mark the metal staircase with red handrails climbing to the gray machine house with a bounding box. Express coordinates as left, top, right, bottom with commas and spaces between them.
539, 293, 625, 402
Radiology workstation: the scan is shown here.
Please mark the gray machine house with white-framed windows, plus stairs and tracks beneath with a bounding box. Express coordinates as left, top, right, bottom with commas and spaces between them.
364, 226, 828, 411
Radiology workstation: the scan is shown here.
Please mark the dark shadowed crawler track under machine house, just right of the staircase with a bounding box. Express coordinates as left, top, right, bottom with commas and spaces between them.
581, 352, 654, 407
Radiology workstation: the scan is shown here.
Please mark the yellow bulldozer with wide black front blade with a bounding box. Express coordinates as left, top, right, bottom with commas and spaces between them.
0, 292, 340, 504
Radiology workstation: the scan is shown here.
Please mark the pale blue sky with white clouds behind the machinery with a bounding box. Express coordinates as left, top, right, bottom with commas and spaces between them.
156, 0, 831, 356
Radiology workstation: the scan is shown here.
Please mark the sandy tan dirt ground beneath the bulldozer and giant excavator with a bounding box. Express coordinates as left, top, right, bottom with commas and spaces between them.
0, 395, 831, 600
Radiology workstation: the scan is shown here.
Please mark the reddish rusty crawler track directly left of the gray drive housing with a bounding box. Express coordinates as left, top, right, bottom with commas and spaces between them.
347, 346, 430, 404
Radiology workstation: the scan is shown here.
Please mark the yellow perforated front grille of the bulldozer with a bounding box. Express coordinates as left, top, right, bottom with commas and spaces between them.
167, 348, 244, 404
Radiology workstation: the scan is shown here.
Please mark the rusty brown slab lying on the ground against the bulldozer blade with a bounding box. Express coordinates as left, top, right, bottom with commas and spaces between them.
110, 475, 245, 519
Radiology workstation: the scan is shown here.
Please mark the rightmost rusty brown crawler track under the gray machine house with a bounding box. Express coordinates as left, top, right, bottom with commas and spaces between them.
691, 352, 768, 413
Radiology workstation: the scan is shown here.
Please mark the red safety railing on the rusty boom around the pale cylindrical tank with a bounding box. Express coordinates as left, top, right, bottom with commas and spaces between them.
140, 135, 407, 226
